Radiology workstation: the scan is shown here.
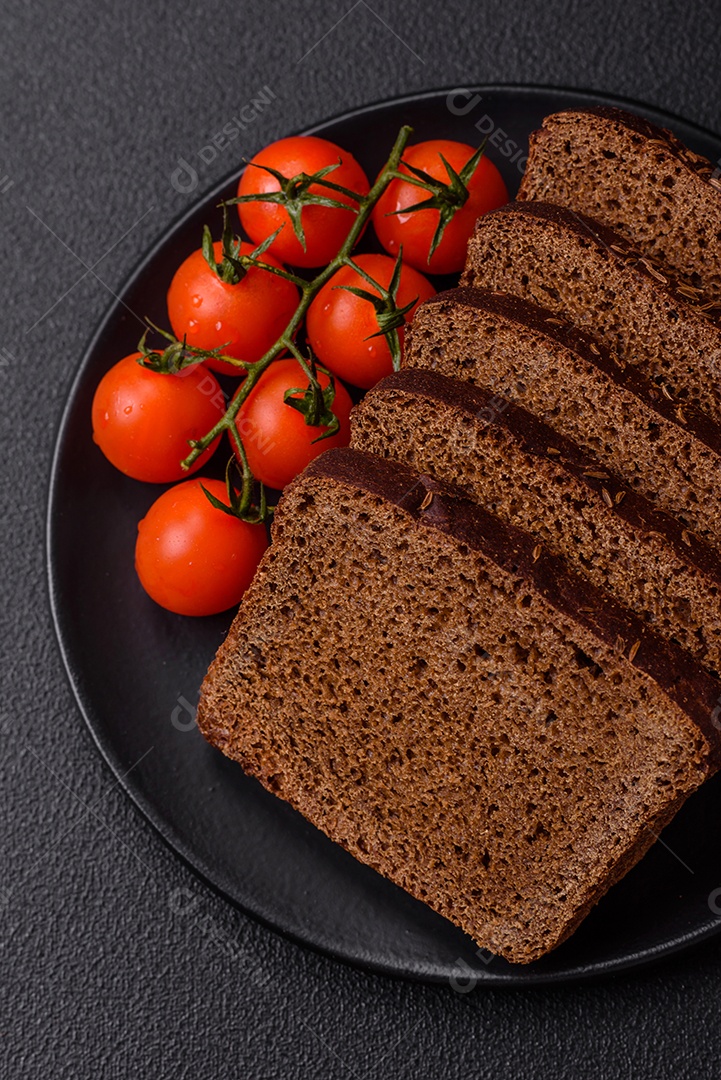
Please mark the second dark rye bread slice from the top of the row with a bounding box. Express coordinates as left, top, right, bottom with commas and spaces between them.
462, 202, 721, 422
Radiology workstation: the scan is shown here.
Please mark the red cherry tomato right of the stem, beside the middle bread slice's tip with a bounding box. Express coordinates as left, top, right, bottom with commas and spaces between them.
305, 255, 435, 390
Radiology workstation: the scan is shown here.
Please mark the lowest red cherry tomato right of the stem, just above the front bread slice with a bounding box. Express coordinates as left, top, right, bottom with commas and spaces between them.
236, 359, 353, 488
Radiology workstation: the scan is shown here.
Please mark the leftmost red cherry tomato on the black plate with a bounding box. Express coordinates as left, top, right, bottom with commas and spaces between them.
92, 352, 226, 484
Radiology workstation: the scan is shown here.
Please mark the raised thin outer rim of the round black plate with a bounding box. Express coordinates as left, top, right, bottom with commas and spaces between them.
43, 82, 721, 989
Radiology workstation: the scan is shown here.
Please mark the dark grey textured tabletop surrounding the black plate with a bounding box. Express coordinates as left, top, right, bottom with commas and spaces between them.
0, 0, 721, 1080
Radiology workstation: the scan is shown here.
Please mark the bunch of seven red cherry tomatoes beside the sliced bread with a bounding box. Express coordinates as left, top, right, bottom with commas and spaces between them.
93, 130, 507, 616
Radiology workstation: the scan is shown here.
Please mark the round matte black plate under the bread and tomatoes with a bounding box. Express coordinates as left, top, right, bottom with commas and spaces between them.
47, 86, 721, 989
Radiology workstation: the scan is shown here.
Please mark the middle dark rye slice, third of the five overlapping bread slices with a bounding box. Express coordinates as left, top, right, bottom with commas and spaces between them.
404, 288, 721, 551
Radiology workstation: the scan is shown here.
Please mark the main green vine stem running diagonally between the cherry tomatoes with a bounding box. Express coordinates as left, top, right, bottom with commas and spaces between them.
182, 126, 412, 477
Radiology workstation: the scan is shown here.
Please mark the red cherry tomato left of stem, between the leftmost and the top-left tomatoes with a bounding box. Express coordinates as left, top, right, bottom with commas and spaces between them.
167, 241, 298, 376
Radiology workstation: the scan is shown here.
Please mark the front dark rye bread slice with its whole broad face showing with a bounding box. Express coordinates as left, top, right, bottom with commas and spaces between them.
198, 449, 719, 962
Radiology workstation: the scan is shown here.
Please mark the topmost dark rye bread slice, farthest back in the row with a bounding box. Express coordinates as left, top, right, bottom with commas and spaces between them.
518, 106, 721, 300
